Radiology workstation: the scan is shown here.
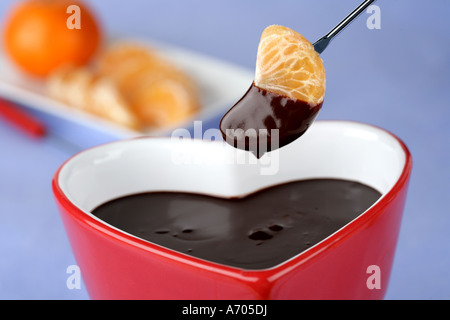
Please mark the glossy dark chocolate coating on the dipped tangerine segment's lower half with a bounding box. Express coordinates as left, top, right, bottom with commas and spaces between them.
220, 83, 322, 158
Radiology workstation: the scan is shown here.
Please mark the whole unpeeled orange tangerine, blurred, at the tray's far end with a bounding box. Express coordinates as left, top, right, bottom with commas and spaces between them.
3, 0, 102, 77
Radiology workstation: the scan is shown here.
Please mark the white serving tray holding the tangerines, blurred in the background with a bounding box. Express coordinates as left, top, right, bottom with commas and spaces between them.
0, 39, 254, 138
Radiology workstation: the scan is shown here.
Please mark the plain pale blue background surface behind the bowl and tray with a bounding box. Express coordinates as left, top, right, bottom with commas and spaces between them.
0, 0, 450, 299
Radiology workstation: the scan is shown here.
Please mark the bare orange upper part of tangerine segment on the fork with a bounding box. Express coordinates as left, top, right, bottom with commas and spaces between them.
255, 25, 326, 105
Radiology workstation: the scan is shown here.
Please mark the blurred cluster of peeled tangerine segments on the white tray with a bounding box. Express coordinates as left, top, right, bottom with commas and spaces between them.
48, 42, 200, 131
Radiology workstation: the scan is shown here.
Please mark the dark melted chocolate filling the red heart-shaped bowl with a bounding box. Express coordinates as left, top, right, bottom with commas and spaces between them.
93, 179, 380, 269
